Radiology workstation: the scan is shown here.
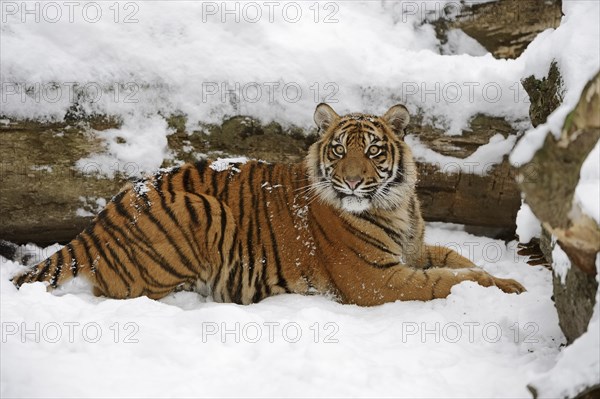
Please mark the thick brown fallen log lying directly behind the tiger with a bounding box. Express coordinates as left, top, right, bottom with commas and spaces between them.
0, 116, 520, 245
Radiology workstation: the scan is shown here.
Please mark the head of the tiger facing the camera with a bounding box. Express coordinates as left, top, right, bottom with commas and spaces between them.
306, 104, 417, 213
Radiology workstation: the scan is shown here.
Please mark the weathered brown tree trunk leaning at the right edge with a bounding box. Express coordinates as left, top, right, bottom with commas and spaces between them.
519, 67, 600, 343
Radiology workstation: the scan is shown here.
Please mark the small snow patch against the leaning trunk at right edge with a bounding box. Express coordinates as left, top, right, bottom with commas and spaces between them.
573, 142, 600, 224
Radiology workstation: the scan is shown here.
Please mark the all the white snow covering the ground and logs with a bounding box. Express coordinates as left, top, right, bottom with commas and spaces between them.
0, 0, 600, 398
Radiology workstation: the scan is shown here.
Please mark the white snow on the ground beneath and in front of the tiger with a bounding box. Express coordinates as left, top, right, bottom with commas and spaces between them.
0, 223, 564, 398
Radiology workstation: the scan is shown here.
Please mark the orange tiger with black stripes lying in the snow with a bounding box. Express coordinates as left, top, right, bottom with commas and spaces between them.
12, 103, 525, 306
